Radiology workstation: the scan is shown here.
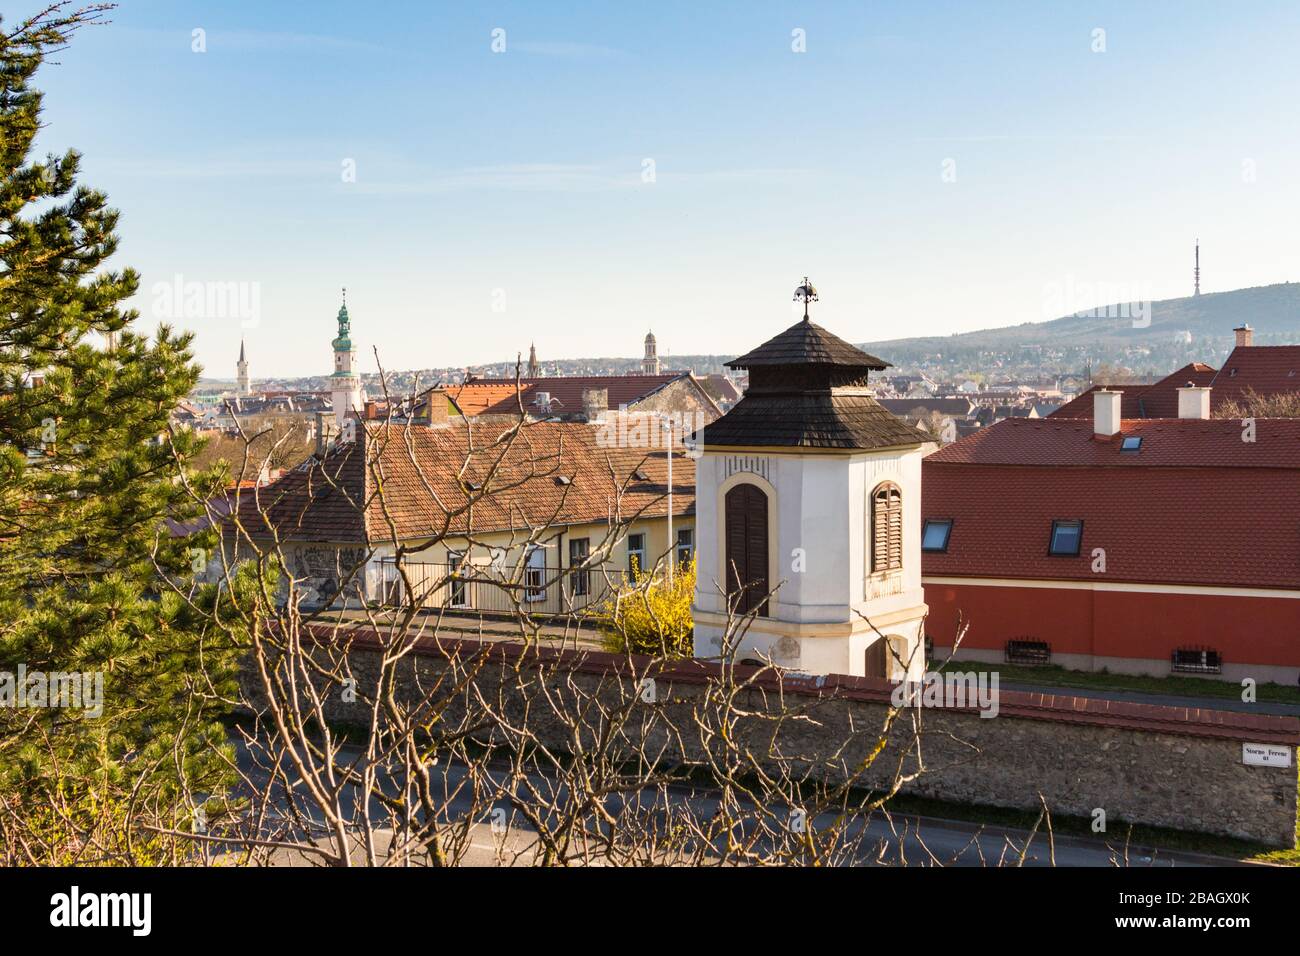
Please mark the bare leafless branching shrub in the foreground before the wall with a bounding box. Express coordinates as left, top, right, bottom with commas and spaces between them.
0, 361, 1102, 866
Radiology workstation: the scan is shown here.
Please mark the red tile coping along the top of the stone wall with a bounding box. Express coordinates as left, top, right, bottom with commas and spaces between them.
304, 624, 1300, 747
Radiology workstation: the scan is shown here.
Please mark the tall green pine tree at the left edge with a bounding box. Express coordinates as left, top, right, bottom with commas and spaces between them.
0, 3, 231, 862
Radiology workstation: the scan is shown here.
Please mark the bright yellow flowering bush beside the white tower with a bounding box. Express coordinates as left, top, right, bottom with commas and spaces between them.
602, 558, 696, 657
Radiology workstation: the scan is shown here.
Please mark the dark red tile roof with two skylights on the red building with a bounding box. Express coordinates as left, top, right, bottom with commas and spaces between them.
922, 419, 1300, 589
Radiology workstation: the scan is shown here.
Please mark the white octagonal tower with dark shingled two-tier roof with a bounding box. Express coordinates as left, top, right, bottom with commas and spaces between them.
693, 280, 933, 680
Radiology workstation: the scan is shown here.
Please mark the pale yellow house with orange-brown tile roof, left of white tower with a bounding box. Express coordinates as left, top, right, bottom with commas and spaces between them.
224, 418, 696, 614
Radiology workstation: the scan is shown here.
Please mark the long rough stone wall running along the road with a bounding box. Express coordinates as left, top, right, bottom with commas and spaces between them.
245, 631, 1300, 847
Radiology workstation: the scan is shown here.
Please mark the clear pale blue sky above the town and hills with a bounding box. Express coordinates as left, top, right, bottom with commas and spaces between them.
22, 0, 1300, 380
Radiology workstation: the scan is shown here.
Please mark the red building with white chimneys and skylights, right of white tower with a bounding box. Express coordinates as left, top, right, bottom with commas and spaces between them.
922, 374, 1300, 684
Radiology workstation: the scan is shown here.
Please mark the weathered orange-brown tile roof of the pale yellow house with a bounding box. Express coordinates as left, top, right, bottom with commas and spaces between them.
228, 421, 696, 542
